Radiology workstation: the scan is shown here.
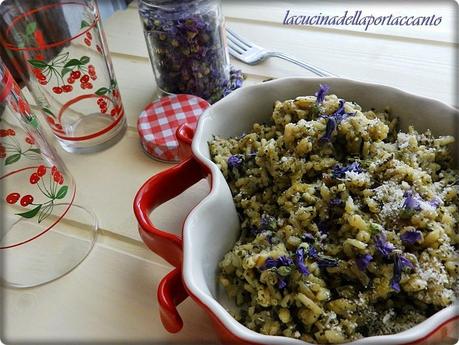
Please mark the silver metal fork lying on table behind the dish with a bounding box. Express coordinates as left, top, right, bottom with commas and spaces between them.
226, 28, 335, 77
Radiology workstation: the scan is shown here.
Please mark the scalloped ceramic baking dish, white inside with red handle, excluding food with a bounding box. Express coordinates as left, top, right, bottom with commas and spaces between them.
134, 78, 459, 345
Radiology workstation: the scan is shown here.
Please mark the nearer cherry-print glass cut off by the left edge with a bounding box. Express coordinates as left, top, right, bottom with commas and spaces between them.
0, 61, 98, 287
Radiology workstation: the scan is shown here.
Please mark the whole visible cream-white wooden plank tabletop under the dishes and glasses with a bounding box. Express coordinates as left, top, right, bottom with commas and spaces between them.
2, 1, 457, 344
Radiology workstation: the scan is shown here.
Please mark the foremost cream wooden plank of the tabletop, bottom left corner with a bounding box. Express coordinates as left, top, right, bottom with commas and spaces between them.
2, 232, 216, 344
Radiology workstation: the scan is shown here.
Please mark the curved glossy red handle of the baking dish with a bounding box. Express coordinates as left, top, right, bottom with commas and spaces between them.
134, 125, 208, 333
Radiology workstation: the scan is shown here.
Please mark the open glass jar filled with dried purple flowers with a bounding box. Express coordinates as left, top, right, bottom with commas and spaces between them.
139, 0, 230, 103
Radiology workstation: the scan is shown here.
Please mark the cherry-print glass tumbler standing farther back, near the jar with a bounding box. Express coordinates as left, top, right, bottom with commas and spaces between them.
0, 0, 126, 152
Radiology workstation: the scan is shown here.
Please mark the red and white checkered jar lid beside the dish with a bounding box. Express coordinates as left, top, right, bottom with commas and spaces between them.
137, 95, 210, 162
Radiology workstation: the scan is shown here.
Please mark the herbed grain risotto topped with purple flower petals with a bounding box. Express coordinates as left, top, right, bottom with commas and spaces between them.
209, 85, 459, 344
